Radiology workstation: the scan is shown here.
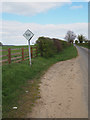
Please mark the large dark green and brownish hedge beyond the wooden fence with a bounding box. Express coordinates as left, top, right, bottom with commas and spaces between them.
36, 37, 70, 57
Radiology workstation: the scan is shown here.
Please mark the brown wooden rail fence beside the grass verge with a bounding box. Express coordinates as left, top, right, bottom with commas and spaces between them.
0, 47, 37, 64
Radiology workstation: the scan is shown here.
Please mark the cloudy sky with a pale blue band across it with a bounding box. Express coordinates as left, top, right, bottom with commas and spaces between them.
0, 0, 88, 45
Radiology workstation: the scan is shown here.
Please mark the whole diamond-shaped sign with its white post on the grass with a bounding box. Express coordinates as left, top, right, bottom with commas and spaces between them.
23, 29, 34, 66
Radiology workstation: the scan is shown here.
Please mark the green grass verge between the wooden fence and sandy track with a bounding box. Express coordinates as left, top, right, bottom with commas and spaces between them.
2, 45, 77, 118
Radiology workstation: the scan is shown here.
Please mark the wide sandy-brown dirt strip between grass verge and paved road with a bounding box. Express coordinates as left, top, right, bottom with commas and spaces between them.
27, 57, 88, 118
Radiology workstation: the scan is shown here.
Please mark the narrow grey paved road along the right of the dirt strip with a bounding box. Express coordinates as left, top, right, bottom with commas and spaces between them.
76, 46, 90, 108
